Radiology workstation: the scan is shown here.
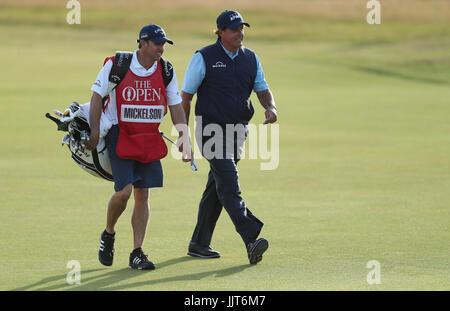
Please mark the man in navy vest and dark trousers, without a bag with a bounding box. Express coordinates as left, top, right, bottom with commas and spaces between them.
181, 10, 277, 264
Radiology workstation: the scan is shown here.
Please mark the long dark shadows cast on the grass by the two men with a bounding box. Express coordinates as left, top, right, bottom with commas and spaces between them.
11, 256, 251, 291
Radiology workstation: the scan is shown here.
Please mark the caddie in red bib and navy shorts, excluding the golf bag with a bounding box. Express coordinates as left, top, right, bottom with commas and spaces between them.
86, 24, 192, 270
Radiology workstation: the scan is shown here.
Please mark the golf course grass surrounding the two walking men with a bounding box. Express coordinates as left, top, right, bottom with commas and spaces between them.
0, 0, 450, 291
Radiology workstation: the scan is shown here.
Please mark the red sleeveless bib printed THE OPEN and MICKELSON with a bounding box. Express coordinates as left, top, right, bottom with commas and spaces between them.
115, 62, 167, 163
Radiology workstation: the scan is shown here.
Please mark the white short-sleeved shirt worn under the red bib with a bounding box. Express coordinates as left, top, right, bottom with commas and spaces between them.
91, 50, 181, 124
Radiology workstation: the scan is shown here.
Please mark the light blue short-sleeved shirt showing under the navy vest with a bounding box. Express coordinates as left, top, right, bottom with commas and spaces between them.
181, 41, 269, 94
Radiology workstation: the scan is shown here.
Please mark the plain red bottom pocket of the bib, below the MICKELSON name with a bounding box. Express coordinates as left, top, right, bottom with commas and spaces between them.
116, 129, 168, 163
